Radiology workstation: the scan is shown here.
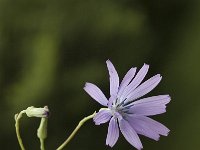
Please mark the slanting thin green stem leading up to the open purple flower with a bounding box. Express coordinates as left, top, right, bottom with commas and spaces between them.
56, 112, 96, 150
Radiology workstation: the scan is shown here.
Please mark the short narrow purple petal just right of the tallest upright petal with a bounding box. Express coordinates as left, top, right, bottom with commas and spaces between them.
118, 68, 136, 98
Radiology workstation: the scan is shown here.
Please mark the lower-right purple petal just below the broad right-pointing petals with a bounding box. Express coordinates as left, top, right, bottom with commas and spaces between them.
128, 116, 170, 136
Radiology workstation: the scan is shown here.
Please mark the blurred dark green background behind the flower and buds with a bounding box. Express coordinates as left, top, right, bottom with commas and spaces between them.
0, 0, 200, 150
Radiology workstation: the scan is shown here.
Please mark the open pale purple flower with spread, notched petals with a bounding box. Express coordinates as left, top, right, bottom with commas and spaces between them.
84, 60, 170, 150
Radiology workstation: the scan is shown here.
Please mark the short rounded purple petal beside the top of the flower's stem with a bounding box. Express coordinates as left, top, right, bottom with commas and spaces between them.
93, 109, 112, 125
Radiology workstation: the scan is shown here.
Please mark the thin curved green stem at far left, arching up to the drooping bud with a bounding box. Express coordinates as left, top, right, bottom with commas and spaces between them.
15, 110, 25, 150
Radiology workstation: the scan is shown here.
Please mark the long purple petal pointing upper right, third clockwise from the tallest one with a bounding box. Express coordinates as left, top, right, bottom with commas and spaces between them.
126, 74, 162, 102
